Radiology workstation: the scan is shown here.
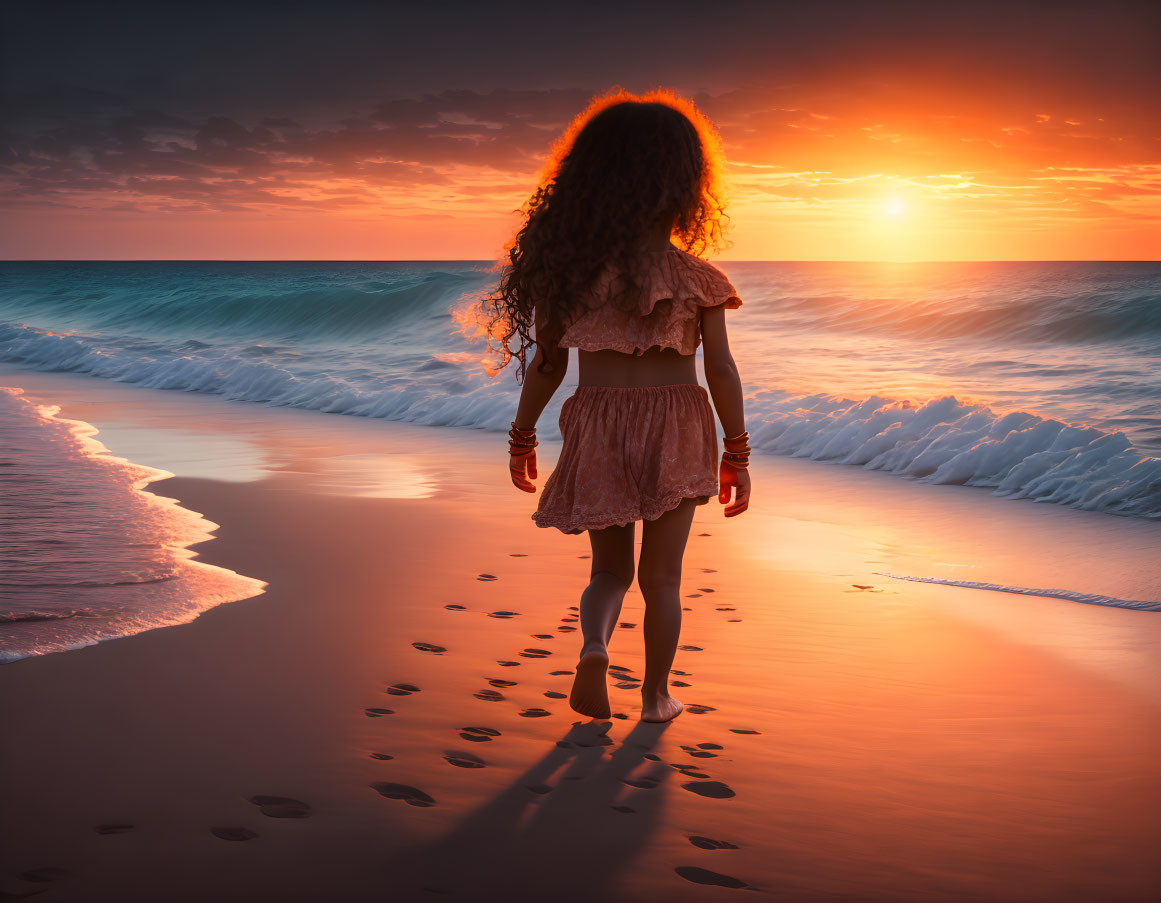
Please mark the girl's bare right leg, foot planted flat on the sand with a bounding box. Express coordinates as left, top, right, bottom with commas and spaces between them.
637, 499, 697, 721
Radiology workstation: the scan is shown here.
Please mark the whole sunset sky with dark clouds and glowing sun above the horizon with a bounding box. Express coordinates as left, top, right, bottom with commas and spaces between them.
0, 0, 1161, 260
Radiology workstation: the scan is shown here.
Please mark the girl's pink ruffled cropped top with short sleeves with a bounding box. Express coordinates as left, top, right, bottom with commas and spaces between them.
560, 247, 742, 354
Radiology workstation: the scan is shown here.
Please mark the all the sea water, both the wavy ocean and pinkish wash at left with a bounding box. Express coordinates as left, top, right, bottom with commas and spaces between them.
0, 261, 1161, 660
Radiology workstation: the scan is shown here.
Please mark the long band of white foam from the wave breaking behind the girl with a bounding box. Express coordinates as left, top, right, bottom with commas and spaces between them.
0, 326, 1161, 518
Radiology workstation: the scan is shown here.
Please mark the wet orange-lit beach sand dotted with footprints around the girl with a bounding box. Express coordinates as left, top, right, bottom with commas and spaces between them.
0, 373, 1161, 903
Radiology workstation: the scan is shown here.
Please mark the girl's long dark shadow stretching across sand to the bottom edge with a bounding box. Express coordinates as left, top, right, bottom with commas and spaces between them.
392, 722, 672, 903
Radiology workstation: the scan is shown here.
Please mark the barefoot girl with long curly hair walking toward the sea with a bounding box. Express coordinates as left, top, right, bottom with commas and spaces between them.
488, 92, 750, 722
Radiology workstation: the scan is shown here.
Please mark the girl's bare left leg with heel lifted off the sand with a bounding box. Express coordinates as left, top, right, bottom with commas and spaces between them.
569, 523, 634, 718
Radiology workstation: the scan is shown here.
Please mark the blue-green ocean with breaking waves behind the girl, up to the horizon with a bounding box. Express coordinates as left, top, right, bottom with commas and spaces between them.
0, 261, 1161, 518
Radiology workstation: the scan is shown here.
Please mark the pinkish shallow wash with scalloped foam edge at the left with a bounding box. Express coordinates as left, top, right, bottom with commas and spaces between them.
0, 389, 265, 662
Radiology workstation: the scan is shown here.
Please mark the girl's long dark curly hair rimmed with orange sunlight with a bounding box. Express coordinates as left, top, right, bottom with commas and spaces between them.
482, 88, 727, 382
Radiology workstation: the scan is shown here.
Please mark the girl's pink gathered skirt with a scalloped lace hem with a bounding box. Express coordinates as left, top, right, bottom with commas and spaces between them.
532, 384, 717, 533
